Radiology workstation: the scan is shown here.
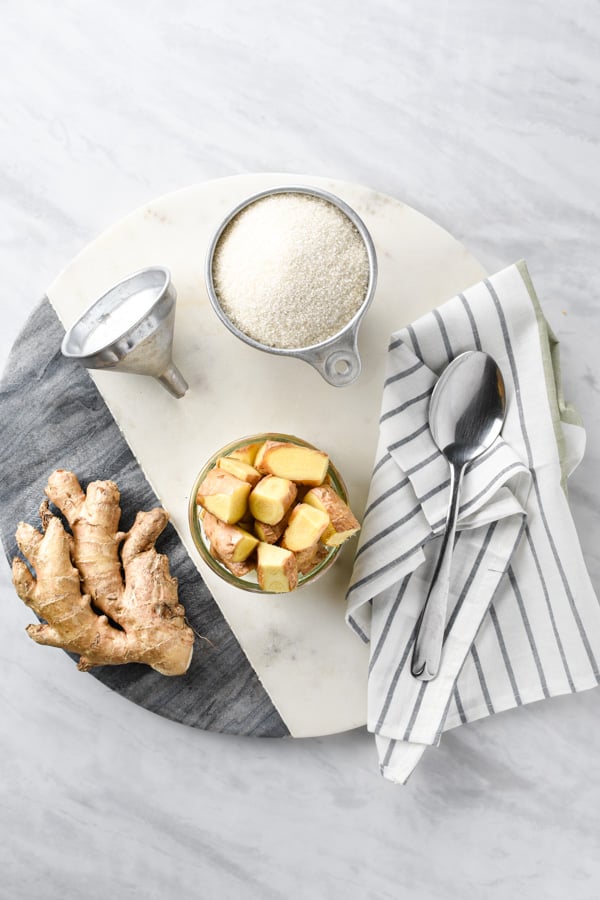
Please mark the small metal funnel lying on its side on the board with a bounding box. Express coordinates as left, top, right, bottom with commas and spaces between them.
61, 266, 188, 398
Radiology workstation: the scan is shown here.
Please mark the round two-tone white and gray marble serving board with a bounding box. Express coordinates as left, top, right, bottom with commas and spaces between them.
0, 174, 485, 737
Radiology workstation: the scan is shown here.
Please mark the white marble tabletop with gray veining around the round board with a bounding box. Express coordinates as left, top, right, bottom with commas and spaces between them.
0, 0, 600, 900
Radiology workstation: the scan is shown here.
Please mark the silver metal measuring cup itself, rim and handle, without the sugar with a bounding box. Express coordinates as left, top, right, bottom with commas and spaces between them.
205, 186, 377, 387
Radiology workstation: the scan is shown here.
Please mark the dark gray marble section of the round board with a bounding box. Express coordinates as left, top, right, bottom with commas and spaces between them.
0, 300, 289, 737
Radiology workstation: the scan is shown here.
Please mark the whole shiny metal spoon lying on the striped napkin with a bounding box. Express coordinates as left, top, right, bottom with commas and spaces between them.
411, 350, 506, 681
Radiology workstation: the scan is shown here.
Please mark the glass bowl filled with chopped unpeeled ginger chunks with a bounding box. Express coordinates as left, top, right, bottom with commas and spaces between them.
189, 432, 360, 594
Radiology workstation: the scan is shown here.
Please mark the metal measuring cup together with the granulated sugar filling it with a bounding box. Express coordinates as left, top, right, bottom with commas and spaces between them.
205, 186, 377, 387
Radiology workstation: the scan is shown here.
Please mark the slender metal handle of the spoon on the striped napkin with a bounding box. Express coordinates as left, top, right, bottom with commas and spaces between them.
411, 463, 466, 681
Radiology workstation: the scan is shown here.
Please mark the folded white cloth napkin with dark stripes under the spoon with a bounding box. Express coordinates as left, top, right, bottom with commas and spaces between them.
347, 262, 600, 783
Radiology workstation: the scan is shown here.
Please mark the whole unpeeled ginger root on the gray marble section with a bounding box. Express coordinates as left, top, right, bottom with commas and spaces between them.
13, 469, 194, 675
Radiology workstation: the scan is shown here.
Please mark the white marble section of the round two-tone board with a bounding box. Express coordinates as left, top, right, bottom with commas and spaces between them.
48, 174, 485, 737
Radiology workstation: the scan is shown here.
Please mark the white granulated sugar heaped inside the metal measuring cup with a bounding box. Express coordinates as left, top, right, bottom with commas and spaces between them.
213, 192, 369, 349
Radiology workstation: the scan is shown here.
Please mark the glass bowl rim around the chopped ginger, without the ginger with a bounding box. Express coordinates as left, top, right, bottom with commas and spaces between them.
188, 432, 348, 594
